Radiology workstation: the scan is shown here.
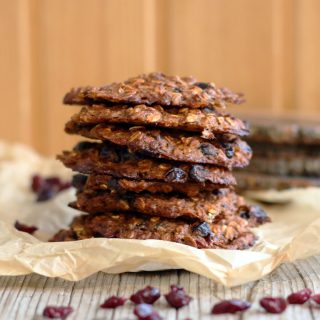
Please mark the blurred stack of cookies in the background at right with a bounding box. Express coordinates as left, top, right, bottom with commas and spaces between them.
236, 119, 320, 190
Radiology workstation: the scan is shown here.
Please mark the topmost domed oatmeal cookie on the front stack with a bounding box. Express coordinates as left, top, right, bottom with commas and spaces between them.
63, 72, 243, 108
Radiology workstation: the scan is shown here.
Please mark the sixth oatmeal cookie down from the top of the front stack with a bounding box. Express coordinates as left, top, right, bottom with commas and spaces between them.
75, 189, 240, 223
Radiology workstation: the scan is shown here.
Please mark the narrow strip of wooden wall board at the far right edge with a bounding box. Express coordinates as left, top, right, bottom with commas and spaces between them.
293, 0, 320, 119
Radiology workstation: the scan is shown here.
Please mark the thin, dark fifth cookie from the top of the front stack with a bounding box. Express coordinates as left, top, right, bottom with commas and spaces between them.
73, 175, 223, 197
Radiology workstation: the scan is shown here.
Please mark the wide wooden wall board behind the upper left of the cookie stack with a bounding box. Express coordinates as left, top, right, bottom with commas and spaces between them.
35, 0, 148, 154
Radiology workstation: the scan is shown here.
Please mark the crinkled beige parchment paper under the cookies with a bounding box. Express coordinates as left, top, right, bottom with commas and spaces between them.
0, 143, 320, 286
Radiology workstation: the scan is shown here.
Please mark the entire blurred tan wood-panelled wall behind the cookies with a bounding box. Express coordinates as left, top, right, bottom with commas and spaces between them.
0, 0, 320, 155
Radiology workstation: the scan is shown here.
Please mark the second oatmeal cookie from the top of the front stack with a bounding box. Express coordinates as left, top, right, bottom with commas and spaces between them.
72, 104, 249, 139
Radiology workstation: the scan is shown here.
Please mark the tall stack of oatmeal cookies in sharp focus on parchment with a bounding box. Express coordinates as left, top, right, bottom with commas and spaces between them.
53, 73, 269, 249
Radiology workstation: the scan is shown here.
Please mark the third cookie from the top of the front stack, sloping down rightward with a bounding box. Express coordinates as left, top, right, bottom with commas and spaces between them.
66, 121, 252, 169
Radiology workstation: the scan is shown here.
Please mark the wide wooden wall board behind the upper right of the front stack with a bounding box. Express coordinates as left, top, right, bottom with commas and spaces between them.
167, 0, 273, 112
